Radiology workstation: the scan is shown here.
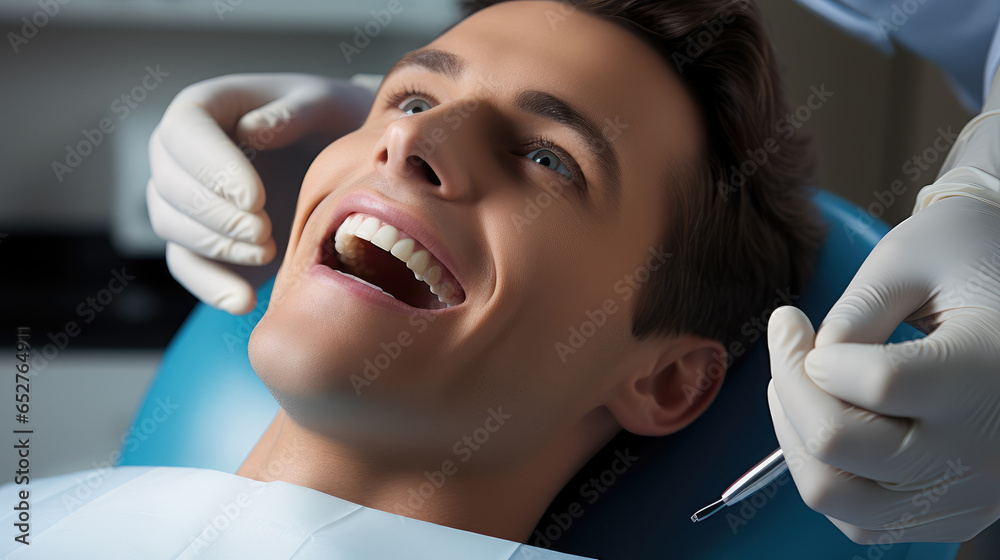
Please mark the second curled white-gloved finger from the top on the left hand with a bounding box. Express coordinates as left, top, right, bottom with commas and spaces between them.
149, 138, 271, 244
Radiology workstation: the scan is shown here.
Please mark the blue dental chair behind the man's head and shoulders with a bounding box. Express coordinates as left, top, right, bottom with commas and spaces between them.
120, 191, 959, 560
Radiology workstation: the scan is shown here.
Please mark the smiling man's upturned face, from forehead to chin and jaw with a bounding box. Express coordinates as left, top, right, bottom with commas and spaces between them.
250, 1, 702, 459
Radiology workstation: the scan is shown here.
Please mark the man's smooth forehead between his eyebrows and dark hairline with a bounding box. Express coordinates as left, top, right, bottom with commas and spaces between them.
427, 0, 702, 205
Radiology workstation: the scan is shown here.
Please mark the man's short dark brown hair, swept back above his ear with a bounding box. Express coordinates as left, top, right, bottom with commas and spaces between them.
463, 0, 825, 356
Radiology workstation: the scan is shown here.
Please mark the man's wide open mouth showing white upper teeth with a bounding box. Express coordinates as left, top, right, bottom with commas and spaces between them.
320, 212, 465, 309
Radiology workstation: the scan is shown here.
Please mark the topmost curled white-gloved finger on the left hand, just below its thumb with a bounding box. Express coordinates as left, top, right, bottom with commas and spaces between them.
150, 97, 265, 212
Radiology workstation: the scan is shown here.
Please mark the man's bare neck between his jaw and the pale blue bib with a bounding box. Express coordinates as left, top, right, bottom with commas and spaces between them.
236, 407, 619, 543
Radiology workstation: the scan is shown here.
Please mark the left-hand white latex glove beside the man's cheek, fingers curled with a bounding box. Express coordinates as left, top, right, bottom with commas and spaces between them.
146, 74, 378, 314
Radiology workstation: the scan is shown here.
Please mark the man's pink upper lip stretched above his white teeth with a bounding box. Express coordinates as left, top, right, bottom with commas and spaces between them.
316, 191, 468, 297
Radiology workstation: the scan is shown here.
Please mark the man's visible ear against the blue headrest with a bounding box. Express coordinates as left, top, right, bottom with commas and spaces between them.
606, 335, 727, 436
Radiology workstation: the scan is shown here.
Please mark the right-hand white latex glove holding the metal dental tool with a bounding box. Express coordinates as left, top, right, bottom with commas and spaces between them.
768, 64, 1000, 544
